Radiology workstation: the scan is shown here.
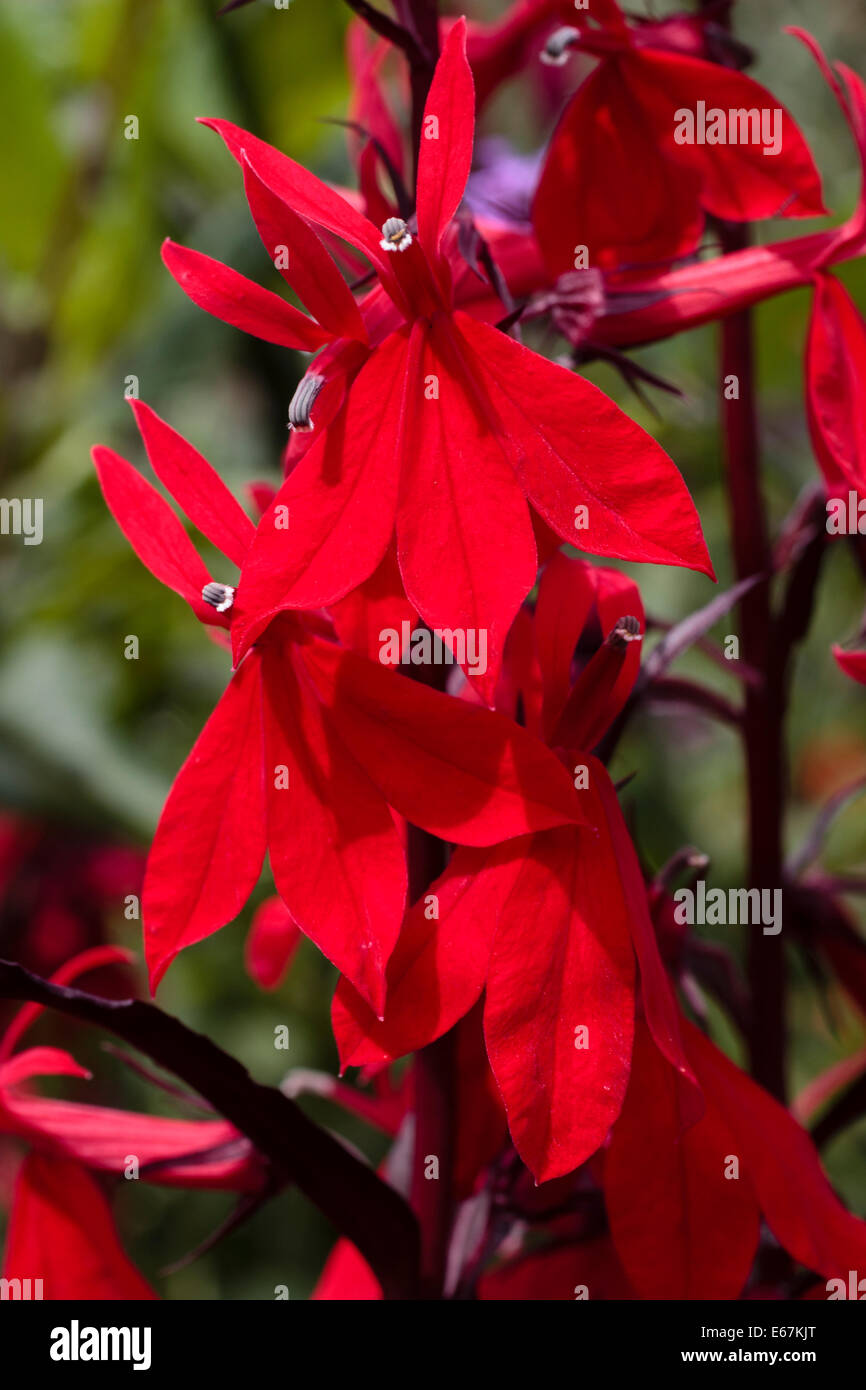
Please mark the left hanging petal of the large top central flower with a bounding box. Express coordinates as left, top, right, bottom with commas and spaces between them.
232, 332, 414, 660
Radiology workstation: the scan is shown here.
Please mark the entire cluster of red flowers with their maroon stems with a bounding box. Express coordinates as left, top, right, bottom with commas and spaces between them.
0, 0, 866, 1300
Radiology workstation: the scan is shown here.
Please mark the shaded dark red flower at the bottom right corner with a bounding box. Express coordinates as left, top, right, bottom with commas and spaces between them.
605, 1020, 866, 1298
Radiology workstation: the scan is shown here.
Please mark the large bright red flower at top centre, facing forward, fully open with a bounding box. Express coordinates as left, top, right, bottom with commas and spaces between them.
164, 21, 712, 698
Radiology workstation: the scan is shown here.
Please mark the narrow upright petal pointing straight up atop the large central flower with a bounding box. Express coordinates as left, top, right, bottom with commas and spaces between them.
417, 19, 475, 257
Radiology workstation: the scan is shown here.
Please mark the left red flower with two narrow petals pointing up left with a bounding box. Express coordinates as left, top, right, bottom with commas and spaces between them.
93, 402, 582, 1012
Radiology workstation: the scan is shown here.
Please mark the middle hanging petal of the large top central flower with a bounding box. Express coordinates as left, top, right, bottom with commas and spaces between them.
398, 320, 537, 703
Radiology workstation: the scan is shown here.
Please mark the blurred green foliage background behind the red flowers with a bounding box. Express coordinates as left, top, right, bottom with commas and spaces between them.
0, 0, 866, 1298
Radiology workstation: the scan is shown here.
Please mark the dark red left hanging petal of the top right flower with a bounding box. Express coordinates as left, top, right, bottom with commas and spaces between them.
532, 61, 703, 277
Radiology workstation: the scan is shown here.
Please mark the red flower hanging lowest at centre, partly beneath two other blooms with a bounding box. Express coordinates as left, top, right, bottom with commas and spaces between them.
332, 555, 694, 1182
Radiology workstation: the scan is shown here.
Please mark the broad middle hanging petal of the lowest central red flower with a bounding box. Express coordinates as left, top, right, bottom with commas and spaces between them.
484, 822, 634, 1183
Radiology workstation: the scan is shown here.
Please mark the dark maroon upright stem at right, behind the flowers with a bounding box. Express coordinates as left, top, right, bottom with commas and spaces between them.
721, 227, 785, 1099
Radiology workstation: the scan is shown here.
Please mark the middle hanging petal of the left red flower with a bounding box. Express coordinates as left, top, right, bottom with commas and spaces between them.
265, 644, 406, 1013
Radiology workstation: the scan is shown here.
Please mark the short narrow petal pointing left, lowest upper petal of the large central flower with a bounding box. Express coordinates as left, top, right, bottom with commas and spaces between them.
163, 240, 332, 352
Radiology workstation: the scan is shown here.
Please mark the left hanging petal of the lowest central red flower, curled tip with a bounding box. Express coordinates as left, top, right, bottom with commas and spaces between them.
331, 840, 525, 1070
